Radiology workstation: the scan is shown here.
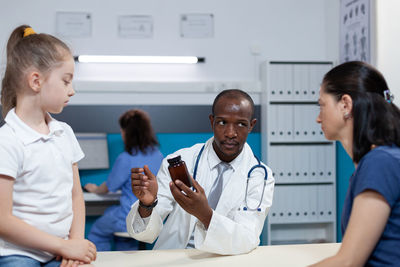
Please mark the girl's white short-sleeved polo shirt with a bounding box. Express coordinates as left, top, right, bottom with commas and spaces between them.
0, 109, 84, 262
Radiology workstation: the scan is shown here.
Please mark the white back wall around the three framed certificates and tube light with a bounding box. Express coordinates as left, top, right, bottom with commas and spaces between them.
0, 0, 339, 102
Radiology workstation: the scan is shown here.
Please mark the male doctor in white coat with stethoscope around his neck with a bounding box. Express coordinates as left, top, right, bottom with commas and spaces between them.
126, 89, 274, 255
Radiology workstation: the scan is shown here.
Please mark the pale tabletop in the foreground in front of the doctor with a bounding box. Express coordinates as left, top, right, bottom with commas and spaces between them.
93, 243, 340, 267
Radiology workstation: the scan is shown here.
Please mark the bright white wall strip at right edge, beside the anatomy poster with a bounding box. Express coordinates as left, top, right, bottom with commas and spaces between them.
376, 0, 400, 103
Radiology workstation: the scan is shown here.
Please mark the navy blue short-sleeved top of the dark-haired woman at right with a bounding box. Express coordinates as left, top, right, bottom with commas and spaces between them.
342, 146, 400, 266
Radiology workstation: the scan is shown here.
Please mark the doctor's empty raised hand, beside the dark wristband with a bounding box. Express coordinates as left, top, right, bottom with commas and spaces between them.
131, 165, 158, 206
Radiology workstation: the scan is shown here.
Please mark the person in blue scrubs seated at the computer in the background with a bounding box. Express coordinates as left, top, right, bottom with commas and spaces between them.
85, 110, 163, 251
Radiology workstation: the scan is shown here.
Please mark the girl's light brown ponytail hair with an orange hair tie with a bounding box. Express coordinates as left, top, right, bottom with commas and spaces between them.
1, 25, 72, 118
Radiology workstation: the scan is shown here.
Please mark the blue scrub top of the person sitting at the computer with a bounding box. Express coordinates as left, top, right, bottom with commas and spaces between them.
106, 147, 163, 229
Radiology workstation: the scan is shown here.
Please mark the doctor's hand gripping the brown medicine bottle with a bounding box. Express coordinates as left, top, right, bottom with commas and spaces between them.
169, 177, 213, 229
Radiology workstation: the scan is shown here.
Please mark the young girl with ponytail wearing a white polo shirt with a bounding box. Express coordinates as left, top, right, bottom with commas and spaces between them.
0, 25, 96, 267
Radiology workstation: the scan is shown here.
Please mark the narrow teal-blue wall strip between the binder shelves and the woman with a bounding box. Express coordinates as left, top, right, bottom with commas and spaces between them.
336, 142, 354, 242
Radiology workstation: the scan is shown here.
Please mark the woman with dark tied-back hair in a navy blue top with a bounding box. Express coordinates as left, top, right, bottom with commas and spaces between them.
315, 61, 400, 266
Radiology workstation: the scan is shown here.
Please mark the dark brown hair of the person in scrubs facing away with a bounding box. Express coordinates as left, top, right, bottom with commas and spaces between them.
119, 109, 158, 155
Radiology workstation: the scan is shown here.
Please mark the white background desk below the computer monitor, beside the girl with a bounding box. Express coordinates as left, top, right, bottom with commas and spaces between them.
83, 192, 121, 216
